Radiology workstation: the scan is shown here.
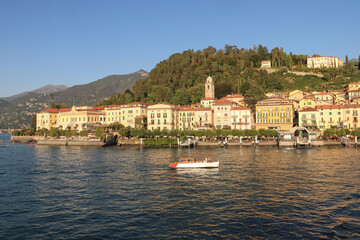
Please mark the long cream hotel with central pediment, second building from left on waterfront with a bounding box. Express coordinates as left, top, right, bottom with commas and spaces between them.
57, 106, 106, 131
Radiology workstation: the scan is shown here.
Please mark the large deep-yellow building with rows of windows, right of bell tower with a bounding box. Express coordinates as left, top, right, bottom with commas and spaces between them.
255, 98, 294, 131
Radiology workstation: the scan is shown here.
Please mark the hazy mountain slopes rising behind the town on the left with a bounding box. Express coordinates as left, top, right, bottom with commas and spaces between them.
0, 70, 148, 129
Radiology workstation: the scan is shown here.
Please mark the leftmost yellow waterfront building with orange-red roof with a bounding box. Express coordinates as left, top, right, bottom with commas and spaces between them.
36, 108, 64, 130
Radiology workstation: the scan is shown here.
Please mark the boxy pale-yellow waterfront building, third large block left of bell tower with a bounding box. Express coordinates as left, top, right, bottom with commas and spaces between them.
147, 103, 178, 130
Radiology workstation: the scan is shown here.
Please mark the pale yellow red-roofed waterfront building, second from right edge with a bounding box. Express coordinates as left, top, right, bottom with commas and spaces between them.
315, 104, 344, 131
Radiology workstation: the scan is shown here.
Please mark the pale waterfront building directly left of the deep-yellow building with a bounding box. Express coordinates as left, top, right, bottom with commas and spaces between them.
230, 106, 252, 130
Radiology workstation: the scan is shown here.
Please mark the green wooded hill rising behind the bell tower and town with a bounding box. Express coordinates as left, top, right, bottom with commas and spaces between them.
97, 45, 360, 109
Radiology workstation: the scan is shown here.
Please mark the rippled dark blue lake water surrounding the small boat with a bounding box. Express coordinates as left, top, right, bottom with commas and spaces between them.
0, 134, 360, 239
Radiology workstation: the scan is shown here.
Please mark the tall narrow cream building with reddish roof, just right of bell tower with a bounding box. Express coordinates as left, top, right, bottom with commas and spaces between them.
213, 100, 237, 129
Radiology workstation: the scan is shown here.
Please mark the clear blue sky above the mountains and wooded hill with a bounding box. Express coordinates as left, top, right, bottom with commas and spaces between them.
0, 0, 360, 97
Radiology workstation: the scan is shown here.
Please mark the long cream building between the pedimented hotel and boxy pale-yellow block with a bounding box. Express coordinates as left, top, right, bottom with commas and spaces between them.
105, 102, 149, 128
